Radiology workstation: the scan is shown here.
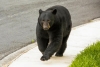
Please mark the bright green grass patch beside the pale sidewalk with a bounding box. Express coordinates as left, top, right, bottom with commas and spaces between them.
69, 41, 100, 67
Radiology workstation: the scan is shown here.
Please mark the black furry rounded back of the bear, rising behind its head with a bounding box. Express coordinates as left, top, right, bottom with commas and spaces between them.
46, 5, 71, 22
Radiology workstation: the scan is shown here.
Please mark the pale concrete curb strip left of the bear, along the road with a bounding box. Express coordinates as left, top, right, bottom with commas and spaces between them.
0, 43, 36, 67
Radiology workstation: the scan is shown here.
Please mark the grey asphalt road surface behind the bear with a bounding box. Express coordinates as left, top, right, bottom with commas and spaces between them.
0, 0, 100, 60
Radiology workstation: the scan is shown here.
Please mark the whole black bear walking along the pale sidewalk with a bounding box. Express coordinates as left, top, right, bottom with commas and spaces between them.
36, 5, 72, 61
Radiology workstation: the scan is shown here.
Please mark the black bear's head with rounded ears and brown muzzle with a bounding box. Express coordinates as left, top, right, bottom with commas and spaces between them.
38, 9, 57, 30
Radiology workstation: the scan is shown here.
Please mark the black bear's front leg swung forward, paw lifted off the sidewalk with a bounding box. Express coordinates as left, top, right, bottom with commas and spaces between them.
41, 32, 63, 61
